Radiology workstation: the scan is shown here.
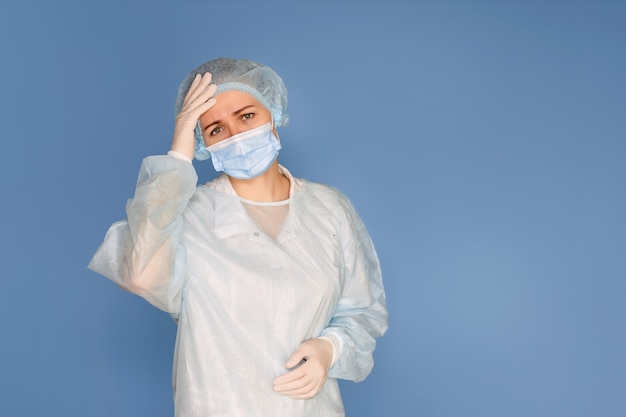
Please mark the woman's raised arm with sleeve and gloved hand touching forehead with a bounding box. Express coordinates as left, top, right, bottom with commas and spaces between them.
89, 73, 215, 315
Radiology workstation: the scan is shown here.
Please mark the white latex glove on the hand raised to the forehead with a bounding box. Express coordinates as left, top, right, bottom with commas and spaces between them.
171, 72, 217, 160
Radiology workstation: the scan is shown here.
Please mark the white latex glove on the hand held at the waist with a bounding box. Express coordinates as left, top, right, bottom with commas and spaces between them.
274, 339, 334, 399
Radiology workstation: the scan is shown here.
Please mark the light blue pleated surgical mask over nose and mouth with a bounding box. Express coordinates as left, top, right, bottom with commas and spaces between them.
206, 123, 280, 180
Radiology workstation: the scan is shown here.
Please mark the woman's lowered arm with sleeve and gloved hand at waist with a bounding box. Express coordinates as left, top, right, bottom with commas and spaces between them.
274, 195, 387, 399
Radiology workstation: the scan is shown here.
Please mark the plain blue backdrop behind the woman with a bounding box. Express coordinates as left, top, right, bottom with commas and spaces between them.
0, 0, 626, 417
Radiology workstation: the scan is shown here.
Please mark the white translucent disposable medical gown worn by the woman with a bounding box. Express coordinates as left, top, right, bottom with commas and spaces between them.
89, 155, 387, 417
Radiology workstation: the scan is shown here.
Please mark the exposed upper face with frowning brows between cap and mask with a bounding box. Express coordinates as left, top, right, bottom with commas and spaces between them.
200, 91, 272, 146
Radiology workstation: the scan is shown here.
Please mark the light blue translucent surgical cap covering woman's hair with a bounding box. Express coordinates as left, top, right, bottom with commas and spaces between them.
176, 58, 289, 160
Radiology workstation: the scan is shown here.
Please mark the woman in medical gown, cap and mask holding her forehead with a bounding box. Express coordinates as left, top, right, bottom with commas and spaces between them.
89, 58, 387, 417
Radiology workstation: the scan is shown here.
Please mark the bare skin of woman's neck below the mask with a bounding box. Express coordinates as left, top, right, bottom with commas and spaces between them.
228, 159, 290, 203
